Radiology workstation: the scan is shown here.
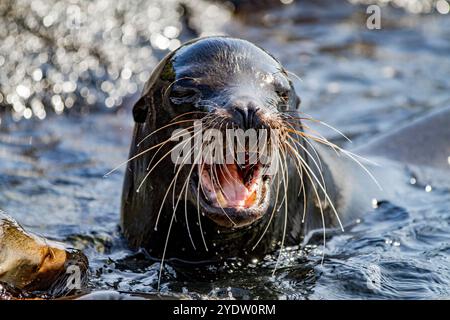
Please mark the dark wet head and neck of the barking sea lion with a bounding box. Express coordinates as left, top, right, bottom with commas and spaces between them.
121, 37, 352, 262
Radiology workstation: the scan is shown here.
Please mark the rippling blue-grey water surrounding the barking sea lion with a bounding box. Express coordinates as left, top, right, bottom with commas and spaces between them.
0, 0, 450, 299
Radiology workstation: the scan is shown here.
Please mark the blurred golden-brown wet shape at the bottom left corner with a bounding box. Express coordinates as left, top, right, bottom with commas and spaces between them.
0, 212, 88, 297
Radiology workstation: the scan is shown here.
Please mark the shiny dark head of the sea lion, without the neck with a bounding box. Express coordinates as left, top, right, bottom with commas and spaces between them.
133, 37, 300, 228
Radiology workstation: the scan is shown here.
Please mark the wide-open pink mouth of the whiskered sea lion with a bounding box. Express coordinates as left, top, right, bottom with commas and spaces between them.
192, 163, 270, 227
